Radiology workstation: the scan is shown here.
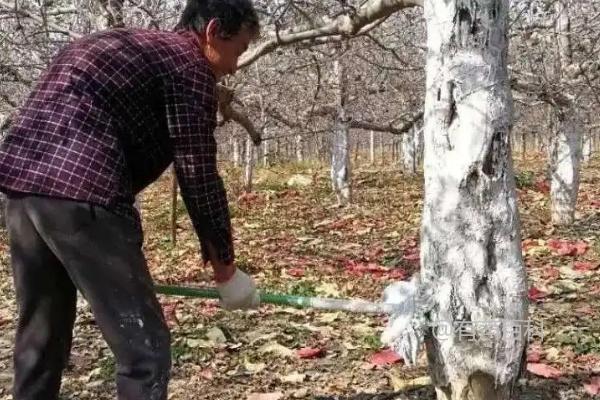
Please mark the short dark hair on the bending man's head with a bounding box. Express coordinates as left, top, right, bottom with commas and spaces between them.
175, 0, 260, 38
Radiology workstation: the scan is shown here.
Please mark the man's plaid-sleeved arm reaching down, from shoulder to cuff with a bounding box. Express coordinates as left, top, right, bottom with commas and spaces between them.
165, 66, 234, 281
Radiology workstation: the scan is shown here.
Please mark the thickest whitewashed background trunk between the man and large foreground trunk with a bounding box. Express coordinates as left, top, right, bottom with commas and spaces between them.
331, 60, 352, 205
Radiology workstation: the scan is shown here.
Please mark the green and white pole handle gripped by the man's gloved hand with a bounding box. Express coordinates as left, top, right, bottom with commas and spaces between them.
155, 285, 404, 314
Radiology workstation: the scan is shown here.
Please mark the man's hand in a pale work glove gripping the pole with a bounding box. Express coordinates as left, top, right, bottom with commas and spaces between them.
217, 268, 260, 310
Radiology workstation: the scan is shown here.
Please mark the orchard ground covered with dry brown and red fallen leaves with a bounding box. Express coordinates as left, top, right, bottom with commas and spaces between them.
0, 154, 600, 400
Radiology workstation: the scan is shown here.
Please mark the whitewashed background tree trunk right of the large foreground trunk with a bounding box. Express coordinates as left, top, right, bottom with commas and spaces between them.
550, 108, 581, 225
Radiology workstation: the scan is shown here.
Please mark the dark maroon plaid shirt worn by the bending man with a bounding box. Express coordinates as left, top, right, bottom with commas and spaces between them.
0, 29, 233, 263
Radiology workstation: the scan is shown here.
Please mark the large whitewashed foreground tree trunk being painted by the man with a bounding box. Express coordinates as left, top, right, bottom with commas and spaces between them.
421, 0, 527, 400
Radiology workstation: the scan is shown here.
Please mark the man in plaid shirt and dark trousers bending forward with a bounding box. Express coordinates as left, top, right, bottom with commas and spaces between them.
0, 0, 259, 400
